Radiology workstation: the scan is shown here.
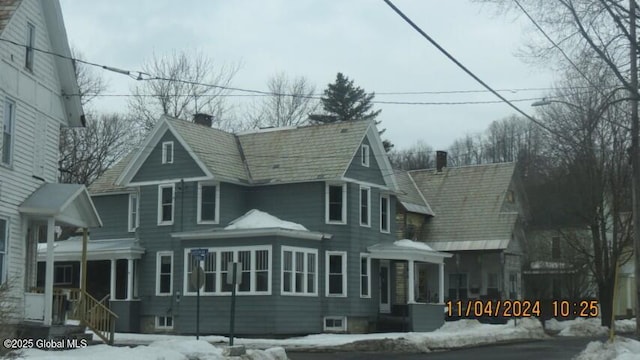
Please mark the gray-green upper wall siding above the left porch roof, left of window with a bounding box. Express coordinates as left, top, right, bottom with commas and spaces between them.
91, 194, 134, 240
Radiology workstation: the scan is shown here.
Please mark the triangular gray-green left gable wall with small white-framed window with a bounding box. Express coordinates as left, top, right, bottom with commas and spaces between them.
132, 131, 205, 183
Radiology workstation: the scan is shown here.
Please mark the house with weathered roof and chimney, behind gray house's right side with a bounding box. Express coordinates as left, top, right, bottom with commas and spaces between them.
397, 152, 528, 300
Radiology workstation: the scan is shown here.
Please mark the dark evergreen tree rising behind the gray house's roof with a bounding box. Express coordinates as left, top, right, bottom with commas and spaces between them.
309, 73, 382, 123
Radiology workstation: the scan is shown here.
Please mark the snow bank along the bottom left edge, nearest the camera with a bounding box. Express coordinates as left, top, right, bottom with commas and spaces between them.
13, 339, 287, 360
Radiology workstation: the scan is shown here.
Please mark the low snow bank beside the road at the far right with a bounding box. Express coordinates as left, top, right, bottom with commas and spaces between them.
545, 318, 636, 336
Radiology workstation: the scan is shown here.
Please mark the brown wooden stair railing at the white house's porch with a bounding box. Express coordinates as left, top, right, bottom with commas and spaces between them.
34, 288, 118, 345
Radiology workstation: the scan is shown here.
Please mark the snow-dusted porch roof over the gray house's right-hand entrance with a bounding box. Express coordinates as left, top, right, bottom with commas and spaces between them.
367, 239, 453, 264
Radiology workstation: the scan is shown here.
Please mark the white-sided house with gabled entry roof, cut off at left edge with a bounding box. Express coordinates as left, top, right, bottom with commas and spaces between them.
0, 0, 100, 324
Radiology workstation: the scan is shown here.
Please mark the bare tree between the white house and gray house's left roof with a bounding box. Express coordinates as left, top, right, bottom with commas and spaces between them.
59, 114, 136, 185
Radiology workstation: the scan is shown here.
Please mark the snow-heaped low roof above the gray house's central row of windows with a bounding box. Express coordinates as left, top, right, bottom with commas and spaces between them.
171, 209, 332, 240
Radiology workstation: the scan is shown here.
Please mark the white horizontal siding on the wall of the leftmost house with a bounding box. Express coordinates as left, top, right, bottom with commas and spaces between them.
0, 0, 74, 315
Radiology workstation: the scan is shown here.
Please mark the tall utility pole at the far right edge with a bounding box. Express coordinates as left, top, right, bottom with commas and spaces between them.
632, 0, 640, 338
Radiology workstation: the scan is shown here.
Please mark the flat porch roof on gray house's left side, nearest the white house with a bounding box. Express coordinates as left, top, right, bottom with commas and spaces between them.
38, 236, 144, 261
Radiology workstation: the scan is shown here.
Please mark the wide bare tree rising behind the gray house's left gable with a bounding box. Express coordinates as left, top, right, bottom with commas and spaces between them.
129, 51, 238, 131
